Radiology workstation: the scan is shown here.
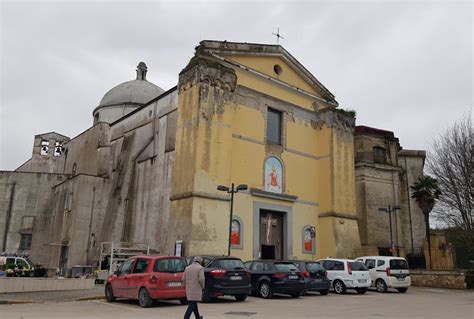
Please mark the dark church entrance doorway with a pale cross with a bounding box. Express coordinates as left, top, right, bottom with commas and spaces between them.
260, 210, 284, 260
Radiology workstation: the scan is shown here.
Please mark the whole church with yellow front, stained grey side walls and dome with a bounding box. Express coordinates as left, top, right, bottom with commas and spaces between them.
0, 41, 424, 276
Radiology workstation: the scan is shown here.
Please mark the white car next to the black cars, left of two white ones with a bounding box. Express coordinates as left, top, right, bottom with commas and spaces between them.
318, 258, 372, 294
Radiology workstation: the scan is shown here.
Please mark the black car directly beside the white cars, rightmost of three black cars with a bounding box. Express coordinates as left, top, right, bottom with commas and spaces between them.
292, 260, 331, 295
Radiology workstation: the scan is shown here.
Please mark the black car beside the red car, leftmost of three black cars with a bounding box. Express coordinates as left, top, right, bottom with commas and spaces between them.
187, 256, 251, 302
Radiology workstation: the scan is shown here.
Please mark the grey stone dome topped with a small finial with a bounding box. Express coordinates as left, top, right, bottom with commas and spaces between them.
93, 62, 164, 124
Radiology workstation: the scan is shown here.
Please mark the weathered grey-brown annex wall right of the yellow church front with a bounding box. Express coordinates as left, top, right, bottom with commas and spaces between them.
354, 132, 425, 254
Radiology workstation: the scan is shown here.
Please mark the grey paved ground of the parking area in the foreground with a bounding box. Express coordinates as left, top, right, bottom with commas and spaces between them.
0, 287, 474, 319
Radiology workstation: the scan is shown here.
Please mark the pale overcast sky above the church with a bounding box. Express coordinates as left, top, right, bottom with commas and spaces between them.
0, 0, 474, 170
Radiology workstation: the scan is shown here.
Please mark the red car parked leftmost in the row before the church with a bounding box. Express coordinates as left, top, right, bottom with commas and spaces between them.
105, 256, 186, 307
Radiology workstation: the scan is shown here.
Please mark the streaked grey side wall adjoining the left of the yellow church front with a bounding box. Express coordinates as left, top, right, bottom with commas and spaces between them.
100, 90, 177, 255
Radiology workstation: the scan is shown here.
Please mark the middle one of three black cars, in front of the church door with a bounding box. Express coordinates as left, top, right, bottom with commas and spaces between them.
245, 260, 305, 298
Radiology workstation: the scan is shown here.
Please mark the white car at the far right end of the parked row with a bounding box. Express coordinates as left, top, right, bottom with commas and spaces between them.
356, 256, 411, 293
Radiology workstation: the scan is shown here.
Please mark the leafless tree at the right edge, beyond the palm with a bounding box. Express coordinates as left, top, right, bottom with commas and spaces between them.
427, 111, 474, 239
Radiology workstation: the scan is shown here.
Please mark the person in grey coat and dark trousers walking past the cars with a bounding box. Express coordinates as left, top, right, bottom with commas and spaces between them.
183, 256, 204, 319
